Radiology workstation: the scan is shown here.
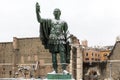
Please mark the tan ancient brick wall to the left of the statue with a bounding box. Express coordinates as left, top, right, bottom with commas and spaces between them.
0, 37, 52, 78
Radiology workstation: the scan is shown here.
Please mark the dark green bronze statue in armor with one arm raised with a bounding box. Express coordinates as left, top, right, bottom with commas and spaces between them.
36, 3, 70, 73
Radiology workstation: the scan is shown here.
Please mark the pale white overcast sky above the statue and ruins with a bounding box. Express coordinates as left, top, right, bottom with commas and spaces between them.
0, 0, 120, 46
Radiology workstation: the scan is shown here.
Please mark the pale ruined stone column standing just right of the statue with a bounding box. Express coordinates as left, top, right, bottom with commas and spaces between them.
70, 44, 83, 80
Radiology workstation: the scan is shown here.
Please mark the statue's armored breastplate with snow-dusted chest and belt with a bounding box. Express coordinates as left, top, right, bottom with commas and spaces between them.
49, 20, 65, 44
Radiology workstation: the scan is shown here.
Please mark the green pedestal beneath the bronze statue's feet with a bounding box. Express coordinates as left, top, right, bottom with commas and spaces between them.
47, 73, 73, 80
